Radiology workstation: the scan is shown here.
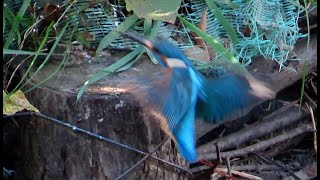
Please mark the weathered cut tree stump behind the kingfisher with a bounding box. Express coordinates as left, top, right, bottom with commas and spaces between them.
17, 53, 188, 180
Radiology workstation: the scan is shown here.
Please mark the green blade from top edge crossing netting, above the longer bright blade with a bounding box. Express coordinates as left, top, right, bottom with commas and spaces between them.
206, 0, 239, 45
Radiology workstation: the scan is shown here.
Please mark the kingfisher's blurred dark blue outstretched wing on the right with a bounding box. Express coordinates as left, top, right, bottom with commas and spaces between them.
196, 72, 274, 123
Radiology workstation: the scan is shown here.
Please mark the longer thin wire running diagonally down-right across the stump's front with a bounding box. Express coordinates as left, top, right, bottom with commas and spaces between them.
2, 112, 191, 174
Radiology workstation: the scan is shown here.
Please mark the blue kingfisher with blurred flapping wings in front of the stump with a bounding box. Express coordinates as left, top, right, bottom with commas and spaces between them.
121, 31, 273, 163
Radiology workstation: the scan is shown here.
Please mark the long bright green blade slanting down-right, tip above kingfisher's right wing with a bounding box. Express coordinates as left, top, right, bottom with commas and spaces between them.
178, 16, 238, 63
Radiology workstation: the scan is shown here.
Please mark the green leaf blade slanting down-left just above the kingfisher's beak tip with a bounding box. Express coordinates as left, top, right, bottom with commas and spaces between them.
96, 14, 139, 54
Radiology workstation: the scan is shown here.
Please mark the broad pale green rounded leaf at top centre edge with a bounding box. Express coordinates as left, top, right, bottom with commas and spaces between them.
125, 0, 181, 22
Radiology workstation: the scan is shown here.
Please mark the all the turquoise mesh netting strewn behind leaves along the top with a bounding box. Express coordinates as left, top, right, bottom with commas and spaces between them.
6, 0, 304, 68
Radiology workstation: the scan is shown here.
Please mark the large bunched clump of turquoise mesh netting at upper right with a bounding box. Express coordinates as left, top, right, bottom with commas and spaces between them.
181, 0, 304, 67
